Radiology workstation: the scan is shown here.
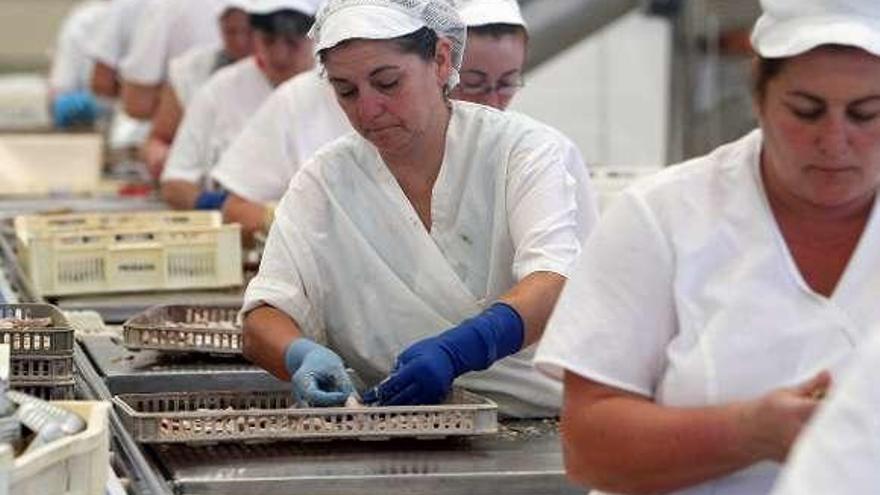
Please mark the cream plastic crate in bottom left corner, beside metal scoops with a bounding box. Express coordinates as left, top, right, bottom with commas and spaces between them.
10, 402, 110, 495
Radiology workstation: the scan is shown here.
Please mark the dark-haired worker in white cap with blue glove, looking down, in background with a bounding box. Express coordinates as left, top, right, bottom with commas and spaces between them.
161, 0, 320, 209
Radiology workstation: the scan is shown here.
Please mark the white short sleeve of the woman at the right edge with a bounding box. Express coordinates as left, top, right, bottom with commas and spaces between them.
535, 193, 678, 397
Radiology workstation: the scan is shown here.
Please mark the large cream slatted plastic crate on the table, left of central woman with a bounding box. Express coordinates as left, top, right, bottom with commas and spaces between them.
15, 211, 242, 296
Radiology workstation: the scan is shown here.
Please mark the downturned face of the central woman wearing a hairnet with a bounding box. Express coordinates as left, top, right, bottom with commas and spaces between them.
324, 40, 450, 155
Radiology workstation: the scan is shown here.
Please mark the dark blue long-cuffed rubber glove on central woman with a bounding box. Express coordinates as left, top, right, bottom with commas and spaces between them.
363, 302, 525, 406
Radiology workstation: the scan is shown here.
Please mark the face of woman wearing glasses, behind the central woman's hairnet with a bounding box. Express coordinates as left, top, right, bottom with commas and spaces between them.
451, 33, 526, 110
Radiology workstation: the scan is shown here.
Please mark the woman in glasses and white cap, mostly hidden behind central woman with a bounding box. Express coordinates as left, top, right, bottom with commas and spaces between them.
211, 0, 596, 244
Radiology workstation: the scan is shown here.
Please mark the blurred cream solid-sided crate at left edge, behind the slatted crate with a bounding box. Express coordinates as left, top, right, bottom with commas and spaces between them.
0, 133, 104, 196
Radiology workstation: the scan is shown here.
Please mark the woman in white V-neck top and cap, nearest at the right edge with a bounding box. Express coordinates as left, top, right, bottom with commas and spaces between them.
535, 0, 880, 495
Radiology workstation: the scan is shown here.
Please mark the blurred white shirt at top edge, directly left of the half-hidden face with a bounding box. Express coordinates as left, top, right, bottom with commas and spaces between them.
120, 0, 225, 86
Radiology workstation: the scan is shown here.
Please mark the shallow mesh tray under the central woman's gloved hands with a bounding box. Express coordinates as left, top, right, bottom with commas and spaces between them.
113, 390, 498, 443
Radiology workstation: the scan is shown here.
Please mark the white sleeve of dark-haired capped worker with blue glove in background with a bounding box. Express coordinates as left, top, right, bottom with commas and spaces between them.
161, 86, 218, 184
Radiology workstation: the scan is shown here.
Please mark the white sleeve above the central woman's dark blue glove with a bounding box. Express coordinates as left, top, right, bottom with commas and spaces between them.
506, 132, 582, 280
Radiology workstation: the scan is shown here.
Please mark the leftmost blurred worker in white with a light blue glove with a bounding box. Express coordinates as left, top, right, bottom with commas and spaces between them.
49, 0, 109, 128
